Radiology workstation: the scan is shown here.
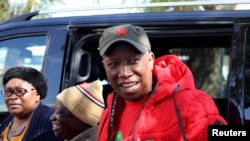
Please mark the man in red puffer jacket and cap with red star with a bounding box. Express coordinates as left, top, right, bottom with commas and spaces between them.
98, 24, 227, 141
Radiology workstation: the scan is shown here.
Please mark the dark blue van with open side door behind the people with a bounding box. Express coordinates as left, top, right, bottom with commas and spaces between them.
0, 1, 250, 124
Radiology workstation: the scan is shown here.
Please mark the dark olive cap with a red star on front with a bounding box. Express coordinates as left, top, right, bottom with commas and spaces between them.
99, 24, 151, 55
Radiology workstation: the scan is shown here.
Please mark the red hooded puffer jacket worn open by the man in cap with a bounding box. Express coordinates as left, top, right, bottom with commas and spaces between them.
98, 55, 227, 141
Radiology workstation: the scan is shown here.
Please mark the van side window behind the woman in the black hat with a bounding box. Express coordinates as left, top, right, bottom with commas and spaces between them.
0, 35, 47, 111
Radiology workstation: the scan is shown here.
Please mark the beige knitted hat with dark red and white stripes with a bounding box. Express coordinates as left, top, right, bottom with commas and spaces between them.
56, 80, 104, 126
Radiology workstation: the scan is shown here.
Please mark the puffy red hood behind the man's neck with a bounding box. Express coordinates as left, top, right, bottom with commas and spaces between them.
153, 55, 195, 101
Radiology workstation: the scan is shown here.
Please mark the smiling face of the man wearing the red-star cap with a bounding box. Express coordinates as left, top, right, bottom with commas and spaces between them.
103, 43, 154, 101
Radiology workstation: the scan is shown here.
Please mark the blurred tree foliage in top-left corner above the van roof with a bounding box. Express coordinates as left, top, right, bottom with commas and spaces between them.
0, 0, 63, 22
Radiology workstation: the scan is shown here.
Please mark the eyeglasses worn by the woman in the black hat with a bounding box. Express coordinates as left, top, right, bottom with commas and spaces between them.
1, 88, 36, 97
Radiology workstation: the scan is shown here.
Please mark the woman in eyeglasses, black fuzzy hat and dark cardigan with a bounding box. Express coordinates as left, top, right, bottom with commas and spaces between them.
0, 67, 63, 141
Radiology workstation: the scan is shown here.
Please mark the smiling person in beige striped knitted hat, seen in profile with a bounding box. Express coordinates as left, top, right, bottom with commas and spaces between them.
50, 80, 104, 141
